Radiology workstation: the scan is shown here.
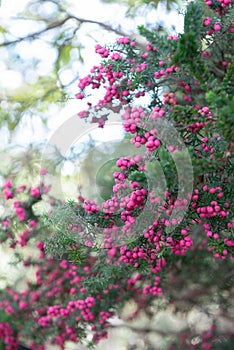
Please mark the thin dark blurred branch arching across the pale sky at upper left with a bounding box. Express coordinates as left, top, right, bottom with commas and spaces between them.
0, 15, 126, 47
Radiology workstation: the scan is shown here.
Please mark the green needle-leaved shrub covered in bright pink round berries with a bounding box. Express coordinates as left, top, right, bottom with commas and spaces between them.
0, 1, 234, 349
